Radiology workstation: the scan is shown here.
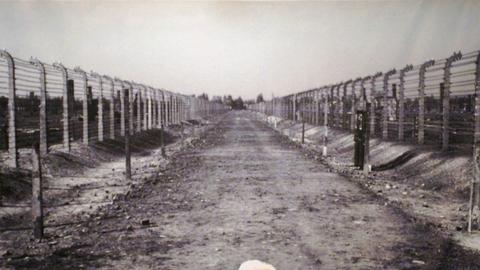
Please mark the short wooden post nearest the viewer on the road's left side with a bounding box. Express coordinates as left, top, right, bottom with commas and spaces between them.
32, 144, 43, 239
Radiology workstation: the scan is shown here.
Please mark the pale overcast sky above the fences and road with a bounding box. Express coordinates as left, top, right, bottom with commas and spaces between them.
0, 0, 480, 98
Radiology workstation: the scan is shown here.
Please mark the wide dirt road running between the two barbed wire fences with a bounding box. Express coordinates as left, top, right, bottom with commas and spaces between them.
10, 112, 450, 270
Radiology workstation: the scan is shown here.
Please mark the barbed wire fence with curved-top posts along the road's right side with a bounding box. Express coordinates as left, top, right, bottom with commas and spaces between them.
248, 51, 480, 231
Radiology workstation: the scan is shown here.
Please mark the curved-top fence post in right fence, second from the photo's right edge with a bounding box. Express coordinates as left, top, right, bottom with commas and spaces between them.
442, 52, 462, 151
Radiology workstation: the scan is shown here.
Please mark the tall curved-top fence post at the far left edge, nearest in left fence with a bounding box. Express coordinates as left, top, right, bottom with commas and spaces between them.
0, 50, 18, 169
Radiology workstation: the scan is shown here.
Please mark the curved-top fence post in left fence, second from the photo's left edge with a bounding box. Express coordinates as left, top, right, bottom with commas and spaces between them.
31, 59, 48, 155
